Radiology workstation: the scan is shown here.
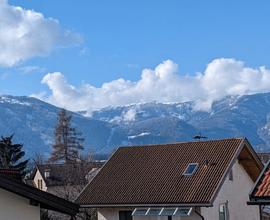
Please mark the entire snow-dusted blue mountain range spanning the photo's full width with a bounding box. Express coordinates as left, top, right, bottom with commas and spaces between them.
0, 93, 270, 159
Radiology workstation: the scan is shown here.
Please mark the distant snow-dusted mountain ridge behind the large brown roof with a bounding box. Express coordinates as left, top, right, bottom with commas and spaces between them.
92, 93, 270, 151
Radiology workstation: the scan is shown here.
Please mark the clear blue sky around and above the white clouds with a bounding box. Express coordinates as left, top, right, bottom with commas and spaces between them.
0, 0, 270, 110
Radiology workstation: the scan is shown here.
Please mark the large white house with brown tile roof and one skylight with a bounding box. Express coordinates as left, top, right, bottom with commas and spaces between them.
76, 138, 263, 220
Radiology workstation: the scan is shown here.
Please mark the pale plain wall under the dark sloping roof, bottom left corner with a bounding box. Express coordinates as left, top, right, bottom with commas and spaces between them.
0, 189, 40, 220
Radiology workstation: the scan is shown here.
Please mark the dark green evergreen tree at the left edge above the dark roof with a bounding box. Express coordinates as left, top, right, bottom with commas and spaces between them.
0, 135, 28, 176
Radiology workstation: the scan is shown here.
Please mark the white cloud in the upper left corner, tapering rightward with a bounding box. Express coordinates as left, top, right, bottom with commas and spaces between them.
0, 0, 82, 67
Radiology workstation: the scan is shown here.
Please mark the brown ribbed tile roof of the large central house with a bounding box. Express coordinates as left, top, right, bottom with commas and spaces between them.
77, 138, 261, 207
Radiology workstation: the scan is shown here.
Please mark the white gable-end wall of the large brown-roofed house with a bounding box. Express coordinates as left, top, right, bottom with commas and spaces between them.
201, 161, 260, 220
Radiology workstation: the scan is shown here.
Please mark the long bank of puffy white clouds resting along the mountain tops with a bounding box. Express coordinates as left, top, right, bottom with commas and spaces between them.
35, 58, 270, 114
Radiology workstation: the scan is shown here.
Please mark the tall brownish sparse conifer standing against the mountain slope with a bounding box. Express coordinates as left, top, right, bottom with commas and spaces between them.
49, 109, 84, 163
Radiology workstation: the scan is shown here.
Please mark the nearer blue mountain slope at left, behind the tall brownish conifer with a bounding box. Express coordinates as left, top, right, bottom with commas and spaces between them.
0, 96, 121, 156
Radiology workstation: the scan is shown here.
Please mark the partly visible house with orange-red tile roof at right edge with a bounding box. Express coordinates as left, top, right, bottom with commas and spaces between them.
248, 161, 270, 220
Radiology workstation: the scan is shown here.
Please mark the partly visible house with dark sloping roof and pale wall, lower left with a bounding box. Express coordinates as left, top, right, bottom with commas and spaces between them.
0, 169, 79, 220
